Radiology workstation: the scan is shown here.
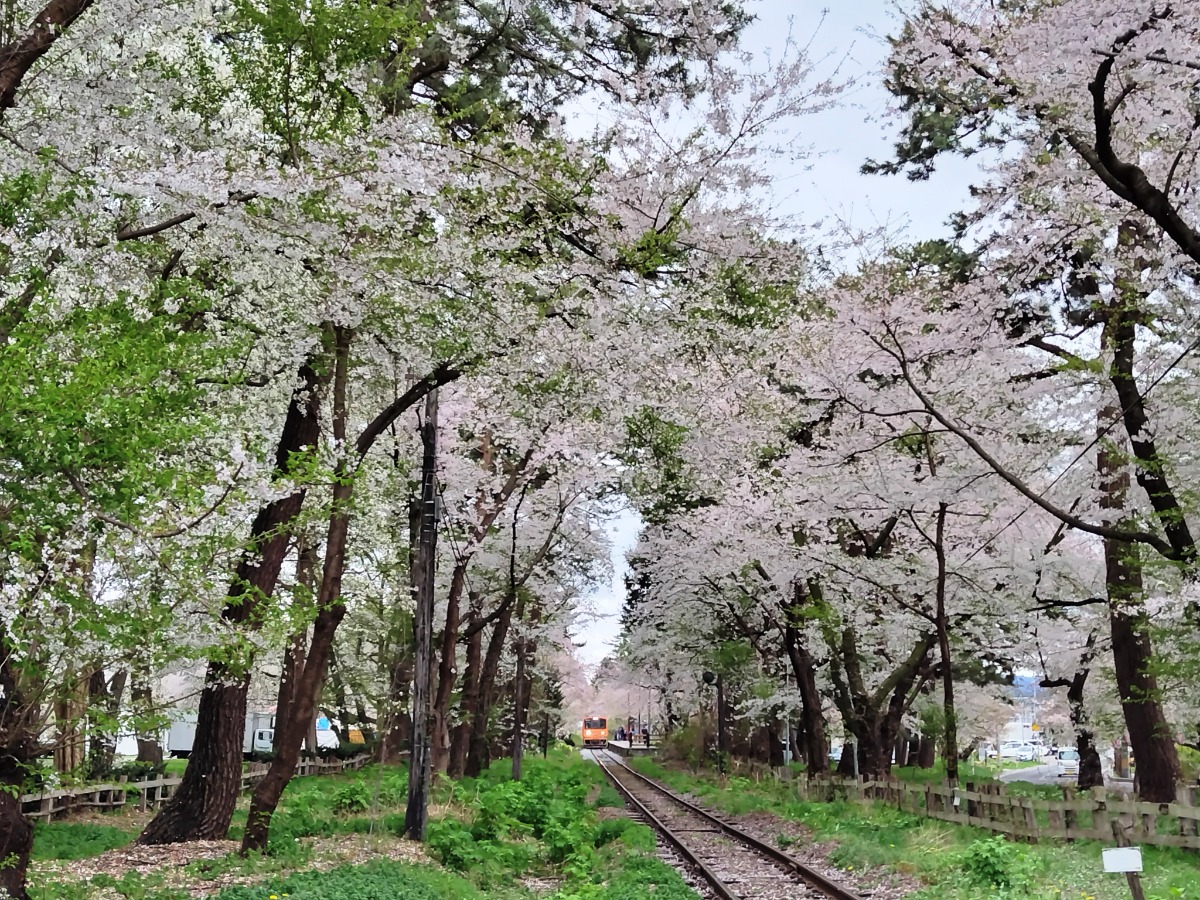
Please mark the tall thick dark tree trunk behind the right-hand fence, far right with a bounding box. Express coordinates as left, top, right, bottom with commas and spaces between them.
1099, 398, 1180, 803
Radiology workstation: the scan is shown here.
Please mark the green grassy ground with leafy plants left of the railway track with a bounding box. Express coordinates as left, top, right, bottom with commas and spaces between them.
31, 750, 696, 900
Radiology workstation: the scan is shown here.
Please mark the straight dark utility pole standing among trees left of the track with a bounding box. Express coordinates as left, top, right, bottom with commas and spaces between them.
404, 388, 438, 841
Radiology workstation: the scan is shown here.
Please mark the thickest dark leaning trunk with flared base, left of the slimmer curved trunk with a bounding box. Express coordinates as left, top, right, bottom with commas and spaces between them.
138, 360, 326, 844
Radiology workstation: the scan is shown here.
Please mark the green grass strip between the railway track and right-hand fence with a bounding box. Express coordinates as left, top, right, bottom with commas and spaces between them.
632, 758, 1200, 900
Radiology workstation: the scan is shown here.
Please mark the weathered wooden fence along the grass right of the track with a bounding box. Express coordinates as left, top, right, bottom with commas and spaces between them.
757, 769, 1200, 850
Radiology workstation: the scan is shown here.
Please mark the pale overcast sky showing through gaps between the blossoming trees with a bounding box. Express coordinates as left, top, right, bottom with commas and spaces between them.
576, 0, 977, 665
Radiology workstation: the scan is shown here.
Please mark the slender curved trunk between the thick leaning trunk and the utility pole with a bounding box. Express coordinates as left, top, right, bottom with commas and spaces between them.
241, 325, 354, 856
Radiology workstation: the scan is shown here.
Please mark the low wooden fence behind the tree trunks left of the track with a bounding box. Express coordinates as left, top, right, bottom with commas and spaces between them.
20, 754, 370, 821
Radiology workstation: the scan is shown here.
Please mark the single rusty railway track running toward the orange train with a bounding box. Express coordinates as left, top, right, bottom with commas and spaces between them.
593, 750, 864, 900
